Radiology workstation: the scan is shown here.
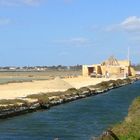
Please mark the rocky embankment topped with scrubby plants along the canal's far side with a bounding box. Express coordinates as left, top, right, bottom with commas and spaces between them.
0, 77, 140, 119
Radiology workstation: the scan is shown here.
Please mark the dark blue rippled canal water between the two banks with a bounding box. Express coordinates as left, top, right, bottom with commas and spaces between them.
0, 82, 140, 140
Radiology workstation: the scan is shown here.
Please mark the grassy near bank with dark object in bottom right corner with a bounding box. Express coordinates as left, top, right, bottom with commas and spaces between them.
97, 96, 140, 140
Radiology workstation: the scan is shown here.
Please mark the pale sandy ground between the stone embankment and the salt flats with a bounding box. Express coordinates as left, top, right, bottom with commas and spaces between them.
0, 76, 118, 99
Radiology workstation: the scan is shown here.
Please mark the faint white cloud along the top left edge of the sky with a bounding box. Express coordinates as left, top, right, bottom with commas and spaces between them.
0, 0, 41, 6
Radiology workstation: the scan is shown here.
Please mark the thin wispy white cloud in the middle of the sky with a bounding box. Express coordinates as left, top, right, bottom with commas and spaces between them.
53, 37, 93, 47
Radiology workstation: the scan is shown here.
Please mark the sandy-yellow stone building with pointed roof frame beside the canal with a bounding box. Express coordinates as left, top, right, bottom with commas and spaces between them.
82, 56, 136, 77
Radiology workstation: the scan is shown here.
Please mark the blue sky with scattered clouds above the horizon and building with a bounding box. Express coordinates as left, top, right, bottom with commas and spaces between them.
0, 0, 140, 66
